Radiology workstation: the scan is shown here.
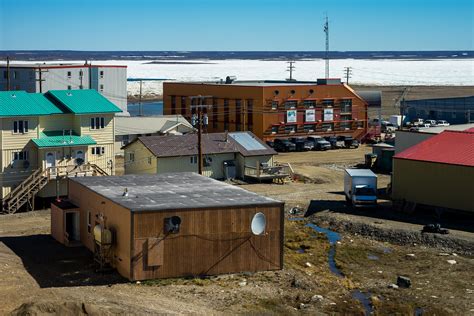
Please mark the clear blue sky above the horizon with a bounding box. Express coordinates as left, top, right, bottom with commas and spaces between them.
0, 0, 474, 51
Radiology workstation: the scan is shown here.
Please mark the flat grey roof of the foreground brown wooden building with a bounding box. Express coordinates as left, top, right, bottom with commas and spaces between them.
69, 172, 283, 212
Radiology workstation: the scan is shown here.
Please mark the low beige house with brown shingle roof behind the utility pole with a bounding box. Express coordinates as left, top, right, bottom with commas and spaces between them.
124, 132, 288, 180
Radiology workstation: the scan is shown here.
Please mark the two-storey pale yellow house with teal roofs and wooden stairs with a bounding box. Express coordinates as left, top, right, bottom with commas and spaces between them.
0, 90, 121, 213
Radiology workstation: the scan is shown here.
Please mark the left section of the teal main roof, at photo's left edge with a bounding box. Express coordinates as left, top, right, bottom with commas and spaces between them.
0, 91, 62, 117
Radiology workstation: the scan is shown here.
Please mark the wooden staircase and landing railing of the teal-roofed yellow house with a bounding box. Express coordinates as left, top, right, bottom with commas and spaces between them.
2, 164, 108, 214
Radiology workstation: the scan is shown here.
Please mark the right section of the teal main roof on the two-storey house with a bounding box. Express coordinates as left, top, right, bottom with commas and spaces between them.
47, 89, 122, 114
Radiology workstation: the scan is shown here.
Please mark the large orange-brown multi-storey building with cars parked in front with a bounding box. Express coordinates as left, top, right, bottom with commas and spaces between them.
163, 79, 368, 140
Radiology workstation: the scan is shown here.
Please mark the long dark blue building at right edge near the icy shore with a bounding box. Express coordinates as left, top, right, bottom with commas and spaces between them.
402, 96, 474, 124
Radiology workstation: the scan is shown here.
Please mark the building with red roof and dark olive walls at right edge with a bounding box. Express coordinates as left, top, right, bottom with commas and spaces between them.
392, 130, 474, 212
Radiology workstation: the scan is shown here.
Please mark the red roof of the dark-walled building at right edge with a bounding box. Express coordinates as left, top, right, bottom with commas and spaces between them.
394, 131, 474, 167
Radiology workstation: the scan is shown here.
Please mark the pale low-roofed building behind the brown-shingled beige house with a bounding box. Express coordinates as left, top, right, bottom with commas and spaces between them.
115, 115, 194, 155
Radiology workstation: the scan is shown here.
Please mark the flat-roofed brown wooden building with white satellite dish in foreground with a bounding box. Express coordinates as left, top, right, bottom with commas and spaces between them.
52, 173, 284, 280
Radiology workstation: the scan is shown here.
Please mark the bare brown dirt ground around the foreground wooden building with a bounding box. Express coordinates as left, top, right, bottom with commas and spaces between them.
0, 146, 474, 315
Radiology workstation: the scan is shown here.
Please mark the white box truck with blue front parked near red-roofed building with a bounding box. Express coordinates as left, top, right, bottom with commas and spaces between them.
344, 169, 377, 207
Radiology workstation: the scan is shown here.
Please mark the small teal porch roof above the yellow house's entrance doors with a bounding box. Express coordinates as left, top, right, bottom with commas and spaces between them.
31, 131, 97, 148
